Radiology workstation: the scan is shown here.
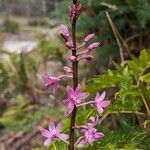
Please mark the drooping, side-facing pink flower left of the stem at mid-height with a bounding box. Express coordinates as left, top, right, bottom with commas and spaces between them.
43, 74, 60, 92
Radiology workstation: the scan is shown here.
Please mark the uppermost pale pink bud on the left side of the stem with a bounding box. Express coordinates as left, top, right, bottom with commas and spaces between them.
60, 24, 70, 42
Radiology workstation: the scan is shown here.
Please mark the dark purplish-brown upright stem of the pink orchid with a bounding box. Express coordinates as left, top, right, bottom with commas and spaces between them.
68, 0, 78, 150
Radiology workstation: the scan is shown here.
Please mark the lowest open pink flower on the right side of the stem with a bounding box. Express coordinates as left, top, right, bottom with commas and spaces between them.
78, 128, 104, 147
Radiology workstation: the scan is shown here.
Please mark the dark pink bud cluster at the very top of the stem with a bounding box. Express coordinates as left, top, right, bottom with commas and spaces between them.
69, 4, 81, 22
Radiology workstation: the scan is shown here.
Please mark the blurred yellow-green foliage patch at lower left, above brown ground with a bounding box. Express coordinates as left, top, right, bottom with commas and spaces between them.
0, 95, 60, 133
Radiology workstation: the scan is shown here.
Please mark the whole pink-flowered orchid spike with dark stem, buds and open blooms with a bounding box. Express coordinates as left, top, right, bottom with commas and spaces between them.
41, 0, 110, 150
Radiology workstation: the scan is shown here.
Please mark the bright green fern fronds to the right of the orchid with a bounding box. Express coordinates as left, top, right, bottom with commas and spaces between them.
87, 50, 150, 112
